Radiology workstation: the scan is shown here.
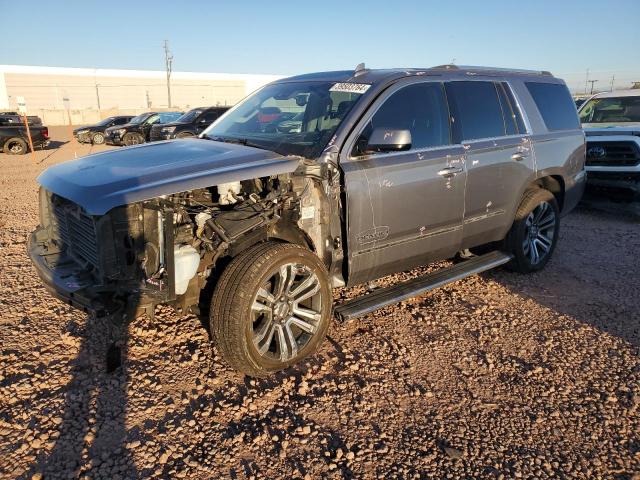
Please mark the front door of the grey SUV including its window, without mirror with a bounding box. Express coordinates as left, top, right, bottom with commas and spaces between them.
341, 81, 466, 285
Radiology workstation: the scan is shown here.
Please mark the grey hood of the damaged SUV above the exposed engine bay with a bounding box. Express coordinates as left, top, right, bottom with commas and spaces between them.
38, 139, 300, 215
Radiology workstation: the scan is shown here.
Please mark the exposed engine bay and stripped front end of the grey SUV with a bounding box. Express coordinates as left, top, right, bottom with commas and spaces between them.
31, 161, 342, 318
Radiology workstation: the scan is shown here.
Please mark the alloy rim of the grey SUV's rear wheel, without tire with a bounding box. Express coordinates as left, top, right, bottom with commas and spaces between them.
522, 202, 557, 265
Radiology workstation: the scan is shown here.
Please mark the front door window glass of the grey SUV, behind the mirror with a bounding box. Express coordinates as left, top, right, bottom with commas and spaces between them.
354, 82, 450, 155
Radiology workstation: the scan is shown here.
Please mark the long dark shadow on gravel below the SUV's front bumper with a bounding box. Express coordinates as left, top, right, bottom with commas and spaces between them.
27, 316, 138, 478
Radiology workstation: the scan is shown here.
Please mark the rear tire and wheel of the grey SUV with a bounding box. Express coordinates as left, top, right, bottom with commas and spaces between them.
506, 188, 560, 273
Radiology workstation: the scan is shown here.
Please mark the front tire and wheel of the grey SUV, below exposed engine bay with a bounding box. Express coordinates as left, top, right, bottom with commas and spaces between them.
210, 242, 333, 377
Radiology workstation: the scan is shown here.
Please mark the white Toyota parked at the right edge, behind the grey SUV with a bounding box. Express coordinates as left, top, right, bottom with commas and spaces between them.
579, 90, 640, 200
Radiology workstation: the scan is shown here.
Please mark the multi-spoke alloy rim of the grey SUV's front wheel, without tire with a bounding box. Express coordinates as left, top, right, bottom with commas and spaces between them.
251, 263, 322, 362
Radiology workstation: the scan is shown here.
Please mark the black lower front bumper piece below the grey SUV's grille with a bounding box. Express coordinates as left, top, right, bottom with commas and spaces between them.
27, 227, 123, 316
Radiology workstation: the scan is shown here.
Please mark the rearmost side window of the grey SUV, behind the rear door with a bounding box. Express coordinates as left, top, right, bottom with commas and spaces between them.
525, 82, 580, 130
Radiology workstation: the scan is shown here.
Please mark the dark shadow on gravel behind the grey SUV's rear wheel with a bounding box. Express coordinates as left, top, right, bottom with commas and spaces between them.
483, 206, 640, 348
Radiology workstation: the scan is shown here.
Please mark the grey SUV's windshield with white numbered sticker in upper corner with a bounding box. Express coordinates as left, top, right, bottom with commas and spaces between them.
204, 82, 369, 158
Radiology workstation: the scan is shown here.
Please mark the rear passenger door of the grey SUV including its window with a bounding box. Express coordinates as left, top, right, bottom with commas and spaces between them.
446, 80, 535, 248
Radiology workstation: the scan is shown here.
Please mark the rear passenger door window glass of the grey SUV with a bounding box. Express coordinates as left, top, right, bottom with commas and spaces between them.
446, 81, 505, 142
